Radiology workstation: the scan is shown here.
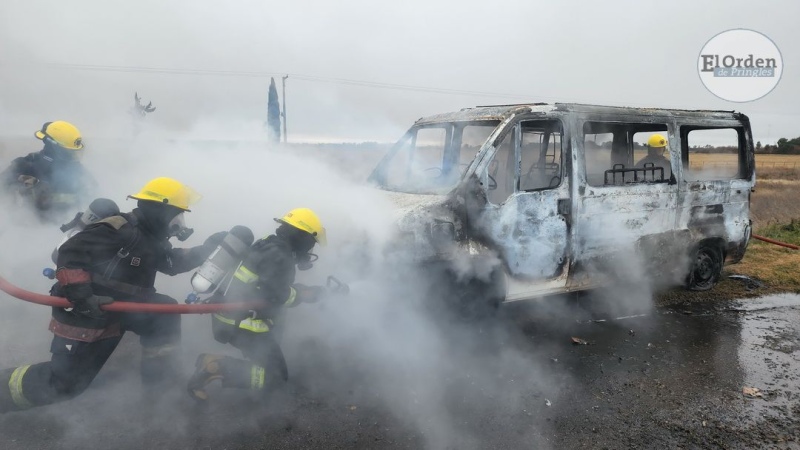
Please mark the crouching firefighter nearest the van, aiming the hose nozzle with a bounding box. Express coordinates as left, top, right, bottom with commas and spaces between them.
188, 208, 326, 401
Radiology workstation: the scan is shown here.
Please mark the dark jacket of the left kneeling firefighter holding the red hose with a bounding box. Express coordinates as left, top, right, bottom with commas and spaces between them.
52, 208, 218, 328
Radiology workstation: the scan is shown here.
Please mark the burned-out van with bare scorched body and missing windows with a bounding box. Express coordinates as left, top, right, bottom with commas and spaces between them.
370, 103, 755, 312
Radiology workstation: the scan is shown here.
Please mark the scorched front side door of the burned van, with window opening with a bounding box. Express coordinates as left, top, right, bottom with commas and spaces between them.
475, 119, 570, 300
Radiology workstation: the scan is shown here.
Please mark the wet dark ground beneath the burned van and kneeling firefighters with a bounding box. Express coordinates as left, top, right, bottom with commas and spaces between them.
0, 288, 800, 450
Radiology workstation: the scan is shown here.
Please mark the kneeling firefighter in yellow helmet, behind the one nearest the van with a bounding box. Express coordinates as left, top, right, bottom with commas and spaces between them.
0, 178, 225, 412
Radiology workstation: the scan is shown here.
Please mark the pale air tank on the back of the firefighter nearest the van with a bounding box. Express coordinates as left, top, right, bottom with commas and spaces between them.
187, 225, 255, 303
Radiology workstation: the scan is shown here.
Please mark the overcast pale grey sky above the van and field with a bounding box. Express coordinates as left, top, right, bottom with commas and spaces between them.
0, 0, 800, 143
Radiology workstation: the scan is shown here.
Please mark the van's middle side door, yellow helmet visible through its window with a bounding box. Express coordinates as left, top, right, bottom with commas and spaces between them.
570, 118, 688, 289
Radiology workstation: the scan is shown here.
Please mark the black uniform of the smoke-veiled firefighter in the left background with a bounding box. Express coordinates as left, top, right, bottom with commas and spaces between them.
0, 145, 97, 220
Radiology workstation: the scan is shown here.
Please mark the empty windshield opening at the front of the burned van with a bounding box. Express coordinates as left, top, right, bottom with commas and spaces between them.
371, 121, 500, 194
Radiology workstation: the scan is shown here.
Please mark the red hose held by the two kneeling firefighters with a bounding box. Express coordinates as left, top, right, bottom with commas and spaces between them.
0, 276, 263, 314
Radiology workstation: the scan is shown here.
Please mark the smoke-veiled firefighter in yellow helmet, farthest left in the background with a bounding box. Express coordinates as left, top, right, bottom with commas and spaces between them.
0, 120, 97, 220
